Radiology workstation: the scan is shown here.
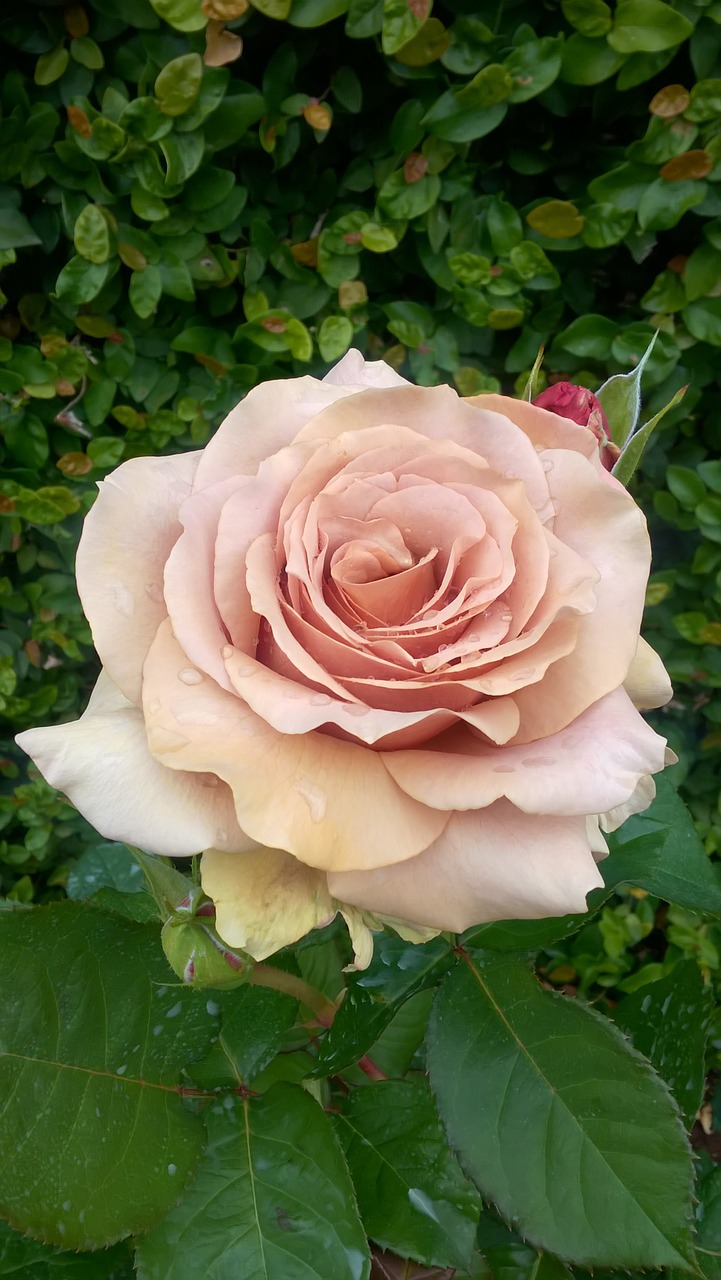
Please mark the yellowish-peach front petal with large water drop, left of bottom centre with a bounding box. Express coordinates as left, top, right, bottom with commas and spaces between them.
143, 622, 448, 869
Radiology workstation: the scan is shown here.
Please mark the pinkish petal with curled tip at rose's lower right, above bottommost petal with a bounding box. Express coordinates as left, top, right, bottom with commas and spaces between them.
384, 689, 666, 814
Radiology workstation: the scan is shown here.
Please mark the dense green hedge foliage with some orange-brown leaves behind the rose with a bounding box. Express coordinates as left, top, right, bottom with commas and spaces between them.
0, 0, 721, 900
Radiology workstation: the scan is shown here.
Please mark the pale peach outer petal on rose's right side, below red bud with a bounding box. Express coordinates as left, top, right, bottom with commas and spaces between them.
516, 449, 651, 742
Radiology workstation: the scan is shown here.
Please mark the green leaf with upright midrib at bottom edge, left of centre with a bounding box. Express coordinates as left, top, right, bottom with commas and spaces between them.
137, 1084, 370, 1280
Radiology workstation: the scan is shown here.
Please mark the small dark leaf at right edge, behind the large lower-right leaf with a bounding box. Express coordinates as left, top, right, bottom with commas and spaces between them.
613, 960, 713, 1129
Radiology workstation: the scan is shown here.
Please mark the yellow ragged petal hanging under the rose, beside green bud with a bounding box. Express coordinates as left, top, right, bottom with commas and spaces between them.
200, 847, 337, 960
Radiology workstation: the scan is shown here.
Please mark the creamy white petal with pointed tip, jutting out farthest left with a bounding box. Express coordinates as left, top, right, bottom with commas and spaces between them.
17, 672, 252, 858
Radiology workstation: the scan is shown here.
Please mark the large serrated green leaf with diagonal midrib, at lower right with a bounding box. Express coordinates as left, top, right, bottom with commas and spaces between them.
428, 952, 693, 1271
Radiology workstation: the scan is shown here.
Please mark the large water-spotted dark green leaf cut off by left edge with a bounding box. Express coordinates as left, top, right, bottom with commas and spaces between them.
0, 902, 215, 1248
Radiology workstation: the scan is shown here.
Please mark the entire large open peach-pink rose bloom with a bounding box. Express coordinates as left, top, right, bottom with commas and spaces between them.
19, 352, 670, 963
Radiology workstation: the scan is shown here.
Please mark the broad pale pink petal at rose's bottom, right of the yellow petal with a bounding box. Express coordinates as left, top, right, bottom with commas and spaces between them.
328, 800, 603, 932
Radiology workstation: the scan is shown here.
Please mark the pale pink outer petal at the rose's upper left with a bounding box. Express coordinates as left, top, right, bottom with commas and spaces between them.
193, 376, 357, 492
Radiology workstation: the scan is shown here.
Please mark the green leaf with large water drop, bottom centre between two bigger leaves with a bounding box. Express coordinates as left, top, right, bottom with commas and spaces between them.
336, 1080, 480, 1267
